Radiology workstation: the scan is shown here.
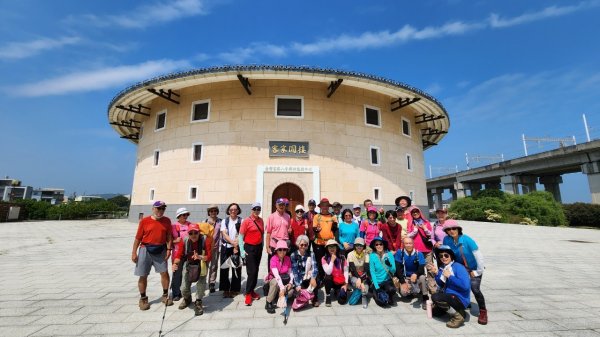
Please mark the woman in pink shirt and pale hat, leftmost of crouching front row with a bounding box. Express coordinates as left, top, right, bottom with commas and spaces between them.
265, 240, 293, 314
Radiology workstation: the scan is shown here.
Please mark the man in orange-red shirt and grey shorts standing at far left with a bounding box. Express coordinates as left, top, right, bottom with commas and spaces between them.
131, 201, 173, 310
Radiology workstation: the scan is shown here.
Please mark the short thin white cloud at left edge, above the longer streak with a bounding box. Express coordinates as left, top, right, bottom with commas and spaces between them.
0, 36, 81, 59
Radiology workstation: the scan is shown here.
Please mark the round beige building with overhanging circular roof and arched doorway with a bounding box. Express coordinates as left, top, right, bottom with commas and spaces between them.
108, 66, 449, 221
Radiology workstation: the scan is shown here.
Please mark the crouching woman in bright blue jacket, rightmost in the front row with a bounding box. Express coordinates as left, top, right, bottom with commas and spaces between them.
427, 245, 471, 328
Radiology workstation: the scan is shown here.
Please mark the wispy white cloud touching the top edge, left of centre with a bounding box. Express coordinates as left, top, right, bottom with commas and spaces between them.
67, 0, 208, 29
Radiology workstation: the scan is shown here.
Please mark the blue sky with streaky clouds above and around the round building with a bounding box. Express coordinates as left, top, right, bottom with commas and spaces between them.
0, 0, 600, 202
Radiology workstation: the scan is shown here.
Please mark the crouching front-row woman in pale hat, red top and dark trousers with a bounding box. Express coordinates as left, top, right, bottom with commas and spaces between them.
321, 239, 348, 307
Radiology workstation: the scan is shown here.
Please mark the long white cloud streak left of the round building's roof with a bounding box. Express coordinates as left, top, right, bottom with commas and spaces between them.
10, 60, 189, 97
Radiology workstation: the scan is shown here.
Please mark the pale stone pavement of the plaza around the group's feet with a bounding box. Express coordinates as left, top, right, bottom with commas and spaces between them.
0, 220, 600, 337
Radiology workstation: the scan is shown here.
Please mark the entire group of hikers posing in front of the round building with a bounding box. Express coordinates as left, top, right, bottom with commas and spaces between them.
131, 196, 487, 328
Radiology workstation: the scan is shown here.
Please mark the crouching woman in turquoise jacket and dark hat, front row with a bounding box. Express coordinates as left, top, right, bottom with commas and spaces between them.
369, 236, 398, 307
